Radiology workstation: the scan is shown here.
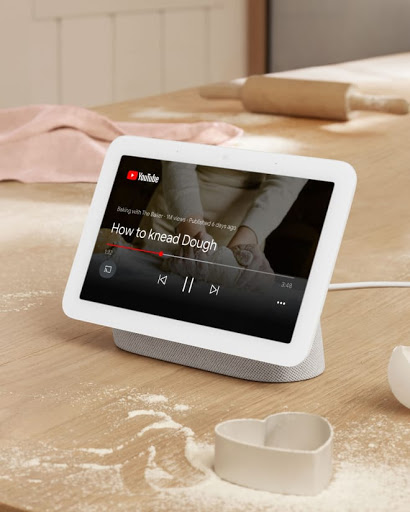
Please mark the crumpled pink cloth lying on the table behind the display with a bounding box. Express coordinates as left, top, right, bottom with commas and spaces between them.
0, 105, 242, 183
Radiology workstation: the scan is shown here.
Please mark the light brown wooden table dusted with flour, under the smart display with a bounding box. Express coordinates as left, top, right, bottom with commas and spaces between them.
0, 54, 410, 512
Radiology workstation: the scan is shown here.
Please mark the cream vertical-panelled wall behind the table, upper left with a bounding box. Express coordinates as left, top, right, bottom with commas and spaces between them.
0, 0, 246, 107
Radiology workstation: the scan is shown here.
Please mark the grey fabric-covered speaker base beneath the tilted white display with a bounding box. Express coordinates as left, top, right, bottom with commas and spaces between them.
113, 325, 325, 382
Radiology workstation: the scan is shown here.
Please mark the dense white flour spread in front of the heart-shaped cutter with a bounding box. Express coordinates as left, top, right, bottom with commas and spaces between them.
145, 440, 410, 512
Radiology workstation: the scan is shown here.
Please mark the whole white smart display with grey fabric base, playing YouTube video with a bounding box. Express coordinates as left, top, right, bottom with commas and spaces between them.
63, 136, 356, 382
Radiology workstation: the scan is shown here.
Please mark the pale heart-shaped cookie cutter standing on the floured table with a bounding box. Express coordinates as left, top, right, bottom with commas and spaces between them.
215, 412, 333, 495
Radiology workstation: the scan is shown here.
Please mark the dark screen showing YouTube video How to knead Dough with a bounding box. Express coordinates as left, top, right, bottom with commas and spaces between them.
80, 156, 333, 343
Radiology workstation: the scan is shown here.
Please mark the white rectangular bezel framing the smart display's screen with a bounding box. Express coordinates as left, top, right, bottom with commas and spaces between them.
63, 136, 356, 366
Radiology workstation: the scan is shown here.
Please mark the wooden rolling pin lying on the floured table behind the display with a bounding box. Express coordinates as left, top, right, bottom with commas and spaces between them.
200, 75, 409, 121
